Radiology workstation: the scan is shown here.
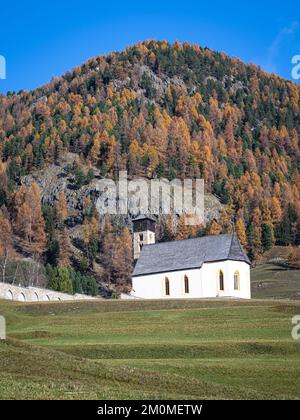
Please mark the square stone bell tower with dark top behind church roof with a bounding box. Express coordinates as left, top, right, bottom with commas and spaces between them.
132, 216, 156, 260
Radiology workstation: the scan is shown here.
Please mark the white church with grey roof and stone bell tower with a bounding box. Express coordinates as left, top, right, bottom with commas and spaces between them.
131, 216, 251, 299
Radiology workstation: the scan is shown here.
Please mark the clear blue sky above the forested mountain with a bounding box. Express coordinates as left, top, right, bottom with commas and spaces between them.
0, 0, 300, 92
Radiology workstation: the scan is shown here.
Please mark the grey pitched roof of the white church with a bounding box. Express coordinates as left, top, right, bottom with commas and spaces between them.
133, 234, 250, 277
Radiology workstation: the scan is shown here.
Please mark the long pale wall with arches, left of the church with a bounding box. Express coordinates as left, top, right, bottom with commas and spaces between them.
0, 283, 95, 302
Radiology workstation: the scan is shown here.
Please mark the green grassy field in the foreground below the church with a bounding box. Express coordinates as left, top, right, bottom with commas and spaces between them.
0, 300, 300, 399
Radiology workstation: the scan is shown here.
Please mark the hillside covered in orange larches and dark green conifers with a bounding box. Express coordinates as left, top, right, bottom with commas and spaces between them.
0, 41, 300, 293
